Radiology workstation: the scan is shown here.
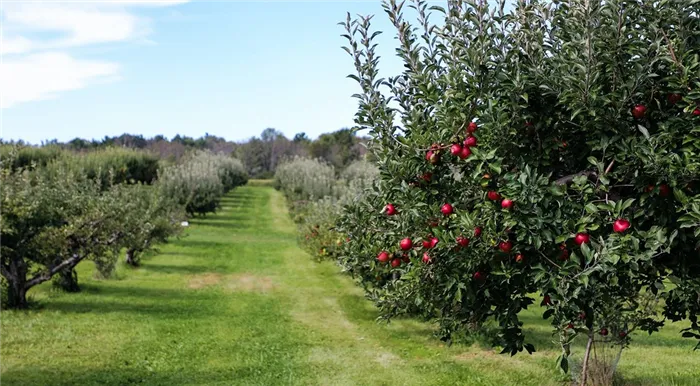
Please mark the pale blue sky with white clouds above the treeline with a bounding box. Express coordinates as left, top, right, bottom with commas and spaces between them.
0, 0, 412, 143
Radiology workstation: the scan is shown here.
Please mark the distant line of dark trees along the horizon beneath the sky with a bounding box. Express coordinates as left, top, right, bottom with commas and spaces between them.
5, 128, 367, 178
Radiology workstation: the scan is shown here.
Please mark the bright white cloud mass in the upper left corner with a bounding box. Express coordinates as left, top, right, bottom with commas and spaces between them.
0, 0, 187, 108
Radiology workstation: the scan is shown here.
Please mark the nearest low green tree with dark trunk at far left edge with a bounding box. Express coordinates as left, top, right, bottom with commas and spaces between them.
0, 165, 146, 308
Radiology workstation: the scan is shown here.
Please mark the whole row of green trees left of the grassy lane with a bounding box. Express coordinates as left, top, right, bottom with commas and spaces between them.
0, 145, 247, 308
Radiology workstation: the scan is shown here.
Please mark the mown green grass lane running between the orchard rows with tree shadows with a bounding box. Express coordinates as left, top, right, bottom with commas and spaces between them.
0, 183, 700, 386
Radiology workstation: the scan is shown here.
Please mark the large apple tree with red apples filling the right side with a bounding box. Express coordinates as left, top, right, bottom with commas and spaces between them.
341, 0, 700, 383
